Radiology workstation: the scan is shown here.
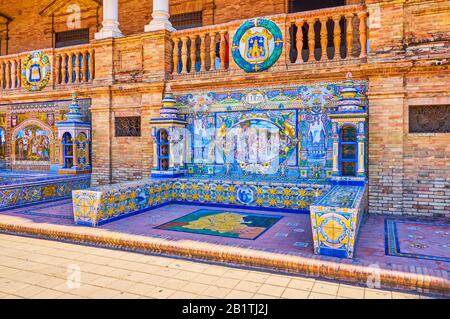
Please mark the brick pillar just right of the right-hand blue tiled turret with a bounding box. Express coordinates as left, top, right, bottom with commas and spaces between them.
368, 75, 405, 214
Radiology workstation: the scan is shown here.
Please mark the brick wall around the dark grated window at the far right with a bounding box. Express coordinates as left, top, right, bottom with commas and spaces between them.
403, 69, 450, 217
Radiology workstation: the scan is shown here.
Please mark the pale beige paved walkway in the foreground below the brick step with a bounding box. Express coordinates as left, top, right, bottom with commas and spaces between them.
0, 234, 429, 299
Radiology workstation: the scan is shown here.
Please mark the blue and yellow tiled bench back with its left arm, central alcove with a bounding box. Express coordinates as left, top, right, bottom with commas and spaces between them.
73, 178, 331, 227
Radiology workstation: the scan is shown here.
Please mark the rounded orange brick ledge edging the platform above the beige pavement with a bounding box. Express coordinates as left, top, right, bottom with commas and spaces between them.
0, 217, 450, 297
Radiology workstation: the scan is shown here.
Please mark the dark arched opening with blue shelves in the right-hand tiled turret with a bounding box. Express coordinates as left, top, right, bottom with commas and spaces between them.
339, 125, 358, 176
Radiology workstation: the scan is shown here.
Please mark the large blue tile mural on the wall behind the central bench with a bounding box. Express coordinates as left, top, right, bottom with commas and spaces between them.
175, 81, 367, 180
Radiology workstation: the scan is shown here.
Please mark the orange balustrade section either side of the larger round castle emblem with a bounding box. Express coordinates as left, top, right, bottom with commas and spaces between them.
171, 5, 367, 76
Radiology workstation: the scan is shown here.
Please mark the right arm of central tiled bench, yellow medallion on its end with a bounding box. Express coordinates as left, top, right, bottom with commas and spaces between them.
310, 185, 367, 258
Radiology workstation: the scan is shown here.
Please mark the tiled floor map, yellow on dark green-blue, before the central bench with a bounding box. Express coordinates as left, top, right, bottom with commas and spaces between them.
156, 209, 283, 240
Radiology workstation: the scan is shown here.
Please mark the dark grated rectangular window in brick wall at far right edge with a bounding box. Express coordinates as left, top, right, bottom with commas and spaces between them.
409, 105, 450, 133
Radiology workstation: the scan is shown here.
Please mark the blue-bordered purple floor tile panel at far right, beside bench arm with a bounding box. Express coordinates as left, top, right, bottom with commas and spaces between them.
384, 218, 450, 262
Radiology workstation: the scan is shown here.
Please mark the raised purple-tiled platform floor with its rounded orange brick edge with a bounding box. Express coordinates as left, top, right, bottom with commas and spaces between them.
0, 200, 450, 295
